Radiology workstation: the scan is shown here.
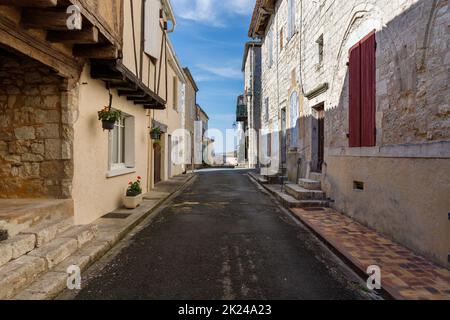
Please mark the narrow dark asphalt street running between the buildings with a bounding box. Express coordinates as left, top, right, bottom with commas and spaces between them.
63, 170, 367, 300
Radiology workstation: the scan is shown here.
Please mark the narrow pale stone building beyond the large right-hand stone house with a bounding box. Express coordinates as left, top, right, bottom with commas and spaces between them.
242, 41, 261, 168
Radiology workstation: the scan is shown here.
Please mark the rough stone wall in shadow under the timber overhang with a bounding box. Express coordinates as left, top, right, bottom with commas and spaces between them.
0, 51, 74, 198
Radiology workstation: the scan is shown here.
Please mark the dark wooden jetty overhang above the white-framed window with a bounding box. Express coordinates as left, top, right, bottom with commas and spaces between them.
91, 59, 166, 110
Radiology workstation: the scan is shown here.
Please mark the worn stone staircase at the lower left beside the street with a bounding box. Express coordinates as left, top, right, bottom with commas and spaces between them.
0, 212, 97, 300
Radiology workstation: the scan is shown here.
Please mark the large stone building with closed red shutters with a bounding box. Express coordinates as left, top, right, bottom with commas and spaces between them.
250, 0, 450, 266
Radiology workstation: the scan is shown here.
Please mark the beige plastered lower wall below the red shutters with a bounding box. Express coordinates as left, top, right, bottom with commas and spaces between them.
324, 156, 450, 265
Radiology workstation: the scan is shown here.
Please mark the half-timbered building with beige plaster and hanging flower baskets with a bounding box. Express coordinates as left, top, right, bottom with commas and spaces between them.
0, 0, 186, 232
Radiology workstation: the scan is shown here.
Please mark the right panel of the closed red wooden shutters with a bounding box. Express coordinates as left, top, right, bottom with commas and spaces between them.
360, 32, 376, 147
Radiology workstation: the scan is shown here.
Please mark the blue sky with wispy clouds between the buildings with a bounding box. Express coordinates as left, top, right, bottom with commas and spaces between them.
170, 0, 254, 152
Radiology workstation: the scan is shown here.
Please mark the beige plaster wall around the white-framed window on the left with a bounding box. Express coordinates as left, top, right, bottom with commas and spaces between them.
73, 66, 149, 224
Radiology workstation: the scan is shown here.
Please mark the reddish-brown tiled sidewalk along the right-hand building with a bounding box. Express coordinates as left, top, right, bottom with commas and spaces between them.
291, 209, 450, 300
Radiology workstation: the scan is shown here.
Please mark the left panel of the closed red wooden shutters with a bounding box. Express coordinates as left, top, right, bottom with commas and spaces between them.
349, 43, 361, 148
